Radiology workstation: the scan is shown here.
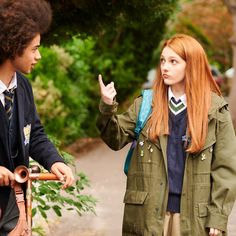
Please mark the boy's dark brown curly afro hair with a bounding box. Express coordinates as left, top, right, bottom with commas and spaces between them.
0, 0, 52, 65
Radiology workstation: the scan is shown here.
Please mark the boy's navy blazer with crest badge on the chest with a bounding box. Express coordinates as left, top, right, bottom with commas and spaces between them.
0, 72, 64, 208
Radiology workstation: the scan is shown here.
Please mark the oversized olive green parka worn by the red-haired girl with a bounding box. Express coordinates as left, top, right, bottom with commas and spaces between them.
97, 93, 236, 236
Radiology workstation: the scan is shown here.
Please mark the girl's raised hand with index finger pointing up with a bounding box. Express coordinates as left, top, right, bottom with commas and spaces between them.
98, 75, 117, 105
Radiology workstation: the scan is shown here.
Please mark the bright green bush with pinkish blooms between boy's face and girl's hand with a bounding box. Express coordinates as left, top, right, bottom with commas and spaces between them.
30, 40, 97, 144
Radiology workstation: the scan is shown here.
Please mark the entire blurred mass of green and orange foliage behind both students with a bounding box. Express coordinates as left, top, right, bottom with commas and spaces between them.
30, 0, 232, 145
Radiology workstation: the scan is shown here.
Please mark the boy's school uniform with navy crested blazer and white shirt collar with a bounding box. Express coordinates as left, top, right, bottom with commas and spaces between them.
0, 72, 64, 235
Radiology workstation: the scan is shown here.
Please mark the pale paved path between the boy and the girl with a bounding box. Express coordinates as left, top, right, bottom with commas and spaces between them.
48, 143, 236, 236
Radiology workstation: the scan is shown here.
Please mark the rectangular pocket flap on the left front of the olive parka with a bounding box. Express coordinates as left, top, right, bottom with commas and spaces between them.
124, 190, 148, 205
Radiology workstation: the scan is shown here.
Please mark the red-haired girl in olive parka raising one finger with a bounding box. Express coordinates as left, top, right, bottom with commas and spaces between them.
98, 34, 236, 236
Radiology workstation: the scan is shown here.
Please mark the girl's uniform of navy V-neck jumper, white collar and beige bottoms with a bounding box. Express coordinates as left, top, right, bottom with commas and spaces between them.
163, 87, 187, 236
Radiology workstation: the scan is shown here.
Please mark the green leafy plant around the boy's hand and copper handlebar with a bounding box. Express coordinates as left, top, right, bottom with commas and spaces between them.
31, 137, 97, 236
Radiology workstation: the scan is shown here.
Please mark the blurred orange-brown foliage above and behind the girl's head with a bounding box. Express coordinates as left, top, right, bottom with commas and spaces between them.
169, 0, 233, 71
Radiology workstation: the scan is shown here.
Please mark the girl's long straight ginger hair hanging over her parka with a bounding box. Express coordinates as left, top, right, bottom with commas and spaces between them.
149, 34, 221, 153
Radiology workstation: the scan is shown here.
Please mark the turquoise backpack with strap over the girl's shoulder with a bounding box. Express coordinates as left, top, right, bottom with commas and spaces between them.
124, 89, 153, 175
